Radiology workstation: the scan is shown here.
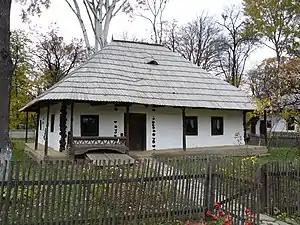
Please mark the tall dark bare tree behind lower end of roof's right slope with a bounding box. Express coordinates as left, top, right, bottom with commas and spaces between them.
219, 6, 256, 87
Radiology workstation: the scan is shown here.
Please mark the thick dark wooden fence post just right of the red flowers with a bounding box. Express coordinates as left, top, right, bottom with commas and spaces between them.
257, 164, 268, 214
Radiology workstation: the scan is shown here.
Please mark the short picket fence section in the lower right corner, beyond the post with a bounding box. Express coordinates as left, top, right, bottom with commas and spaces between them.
260, 160, 300, 216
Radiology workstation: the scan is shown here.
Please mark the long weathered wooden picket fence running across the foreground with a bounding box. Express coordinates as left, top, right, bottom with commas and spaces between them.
0, 156, 299, 225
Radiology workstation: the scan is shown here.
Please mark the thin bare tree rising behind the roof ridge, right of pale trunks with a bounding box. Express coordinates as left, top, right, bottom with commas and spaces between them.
137, 0, 169, 44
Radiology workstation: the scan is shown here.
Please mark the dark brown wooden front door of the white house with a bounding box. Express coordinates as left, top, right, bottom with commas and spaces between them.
124, 113, 146, 151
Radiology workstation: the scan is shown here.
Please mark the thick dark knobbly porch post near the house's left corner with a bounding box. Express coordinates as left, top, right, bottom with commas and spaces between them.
59, 101, 67, 152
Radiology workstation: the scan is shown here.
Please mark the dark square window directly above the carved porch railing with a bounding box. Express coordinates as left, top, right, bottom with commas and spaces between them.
80, 115, 99, 136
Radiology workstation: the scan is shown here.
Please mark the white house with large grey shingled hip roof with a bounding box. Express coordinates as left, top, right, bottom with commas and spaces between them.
21, 40, 253, 156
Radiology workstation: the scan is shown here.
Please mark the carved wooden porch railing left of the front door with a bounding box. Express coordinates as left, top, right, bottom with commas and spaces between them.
68, 133, 128, 155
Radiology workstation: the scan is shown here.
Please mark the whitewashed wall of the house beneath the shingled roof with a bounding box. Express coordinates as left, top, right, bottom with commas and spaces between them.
39, 103, 243, 150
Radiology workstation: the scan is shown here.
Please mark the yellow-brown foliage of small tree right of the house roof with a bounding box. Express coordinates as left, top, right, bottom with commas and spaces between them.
251, 57, 300, 115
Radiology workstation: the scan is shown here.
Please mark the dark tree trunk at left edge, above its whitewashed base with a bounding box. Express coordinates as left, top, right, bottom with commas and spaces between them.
0, 0, 12, 151
